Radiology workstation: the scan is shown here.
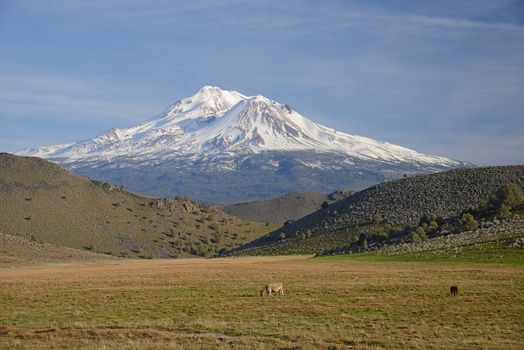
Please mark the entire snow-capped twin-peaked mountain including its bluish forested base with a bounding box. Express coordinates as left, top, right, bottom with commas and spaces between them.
17, 86, 468, 203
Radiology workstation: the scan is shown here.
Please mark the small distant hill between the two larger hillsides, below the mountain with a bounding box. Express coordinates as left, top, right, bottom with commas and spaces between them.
217, 191, 352, 224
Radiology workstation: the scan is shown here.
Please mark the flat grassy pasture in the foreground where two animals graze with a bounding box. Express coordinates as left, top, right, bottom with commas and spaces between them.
0, 256, 524, 349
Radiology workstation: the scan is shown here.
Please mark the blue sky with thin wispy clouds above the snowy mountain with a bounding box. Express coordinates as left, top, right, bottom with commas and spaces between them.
0, 0, 524, 165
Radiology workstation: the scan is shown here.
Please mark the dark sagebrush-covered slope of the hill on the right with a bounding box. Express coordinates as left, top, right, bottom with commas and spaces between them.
230, 165, 524, 254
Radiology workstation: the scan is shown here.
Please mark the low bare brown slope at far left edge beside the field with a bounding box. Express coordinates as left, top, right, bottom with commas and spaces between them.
0, 232, 116, 266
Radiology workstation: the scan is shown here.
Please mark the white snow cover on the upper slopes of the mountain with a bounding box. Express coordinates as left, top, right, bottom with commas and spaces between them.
18, 86, 462, 168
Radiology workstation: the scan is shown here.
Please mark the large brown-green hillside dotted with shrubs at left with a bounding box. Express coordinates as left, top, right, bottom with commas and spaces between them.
0, 153, 272, 258
